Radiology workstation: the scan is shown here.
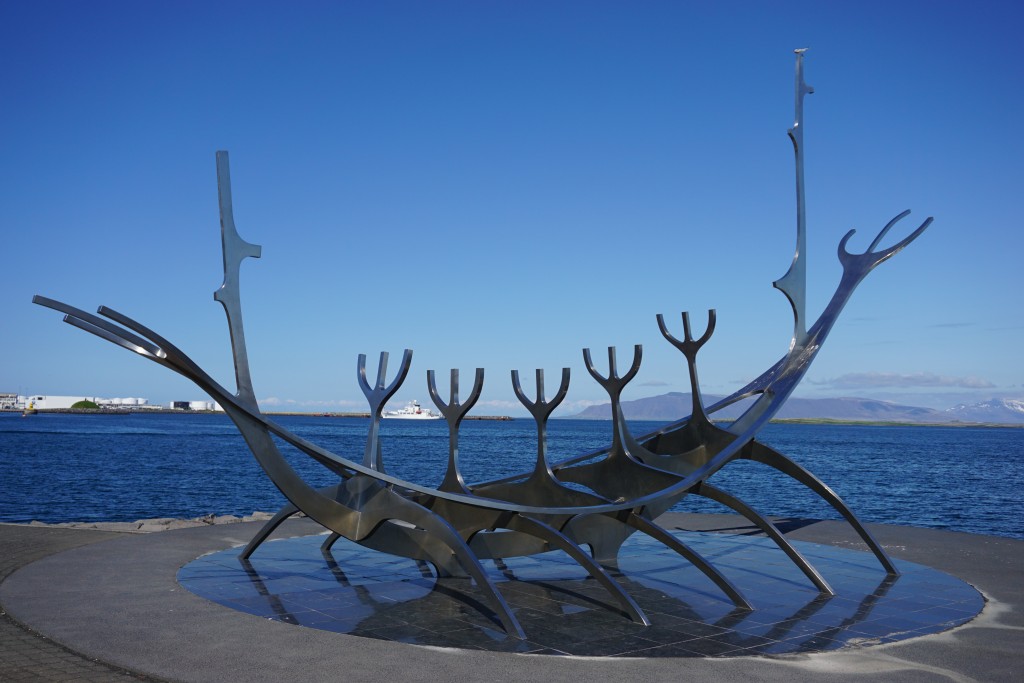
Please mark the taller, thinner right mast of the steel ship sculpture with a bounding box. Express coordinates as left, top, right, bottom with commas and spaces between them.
772, 47, 814, 347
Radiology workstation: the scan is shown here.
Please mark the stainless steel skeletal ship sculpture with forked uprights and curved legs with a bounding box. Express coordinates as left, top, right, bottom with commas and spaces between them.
33, 50, 932, 637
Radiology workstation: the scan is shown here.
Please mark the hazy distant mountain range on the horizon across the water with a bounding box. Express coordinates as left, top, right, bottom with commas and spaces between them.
572, 391, 1024, 425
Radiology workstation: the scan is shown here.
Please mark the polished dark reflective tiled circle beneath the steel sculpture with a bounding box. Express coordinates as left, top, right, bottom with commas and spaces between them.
178, 531, 984, 657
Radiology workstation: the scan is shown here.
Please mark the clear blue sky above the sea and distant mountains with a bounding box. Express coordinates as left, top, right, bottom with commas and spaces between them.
0, 0, 1024, 415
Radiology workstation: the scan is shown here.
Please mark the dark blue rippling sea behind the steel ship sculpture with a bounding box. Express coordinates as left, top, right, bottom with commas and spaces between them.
0, 413, 1024, 539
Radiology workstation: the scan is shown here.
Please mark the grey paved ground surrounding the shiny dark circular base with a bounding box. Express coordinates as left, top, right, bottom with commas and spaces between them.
0, 514, 1024, 683
